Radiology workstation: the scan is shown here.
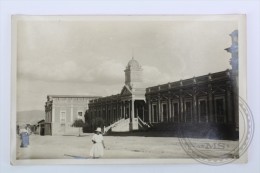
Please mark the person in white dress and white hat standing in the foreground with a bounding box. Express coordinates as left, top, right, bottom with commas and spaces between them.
90, 127, 105, 159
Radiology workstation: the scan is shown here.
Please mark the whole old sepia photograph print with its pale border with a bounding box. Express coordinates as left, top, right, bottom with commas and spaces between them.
11, 15, 247, 164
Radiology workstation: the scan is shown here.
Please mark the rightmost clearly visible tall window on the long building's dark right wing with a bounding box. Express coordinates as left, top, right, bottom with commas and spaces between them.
215, 97, 225, 123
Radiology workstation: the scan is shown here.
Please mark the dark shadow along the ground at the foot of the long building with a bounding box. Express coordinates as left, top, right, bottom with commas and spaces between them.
106, 123, 238, 141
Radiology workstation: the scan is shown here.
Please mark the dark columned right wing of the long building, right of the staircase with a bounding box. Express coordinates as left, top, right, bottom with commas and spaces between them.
146, 70, 235, 125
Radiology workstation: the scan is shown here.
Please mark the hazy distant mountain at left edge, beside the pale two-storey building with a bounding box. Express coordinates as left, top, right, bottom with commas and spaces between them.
16, 110, 45, 124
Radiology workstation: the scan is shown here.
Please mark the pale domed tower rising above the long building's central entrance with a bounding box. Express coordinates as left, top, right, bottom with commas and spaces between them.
125, 57, 143, 88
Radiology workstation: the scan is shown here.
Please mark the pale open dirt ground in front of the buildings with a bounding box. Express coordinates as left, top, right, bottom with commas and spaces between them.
16, 133, 237, 159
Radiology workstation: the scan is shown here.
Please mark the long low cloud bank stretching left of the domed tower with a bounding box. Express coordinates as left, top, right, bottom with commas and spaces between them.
18, 60, 124, 85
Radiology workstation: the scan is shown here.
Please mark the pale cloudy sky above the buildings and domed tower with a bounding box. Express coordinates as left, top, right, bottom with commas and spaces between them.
17, 17, 238, 111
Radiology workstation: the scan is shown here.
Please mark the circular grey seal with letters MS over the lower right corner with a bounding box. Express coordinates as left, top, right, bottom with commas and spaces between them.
178, 97, 254, 165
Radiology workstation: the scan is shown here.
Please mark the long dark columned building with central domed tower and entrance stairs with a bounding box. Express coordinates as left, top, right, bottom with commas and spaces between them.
88, 30, 238, 138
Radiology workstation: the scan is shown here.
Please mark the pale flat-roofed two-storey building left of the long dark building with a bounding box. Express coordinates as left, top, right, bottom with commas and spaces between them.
44, 95, 98, 135
